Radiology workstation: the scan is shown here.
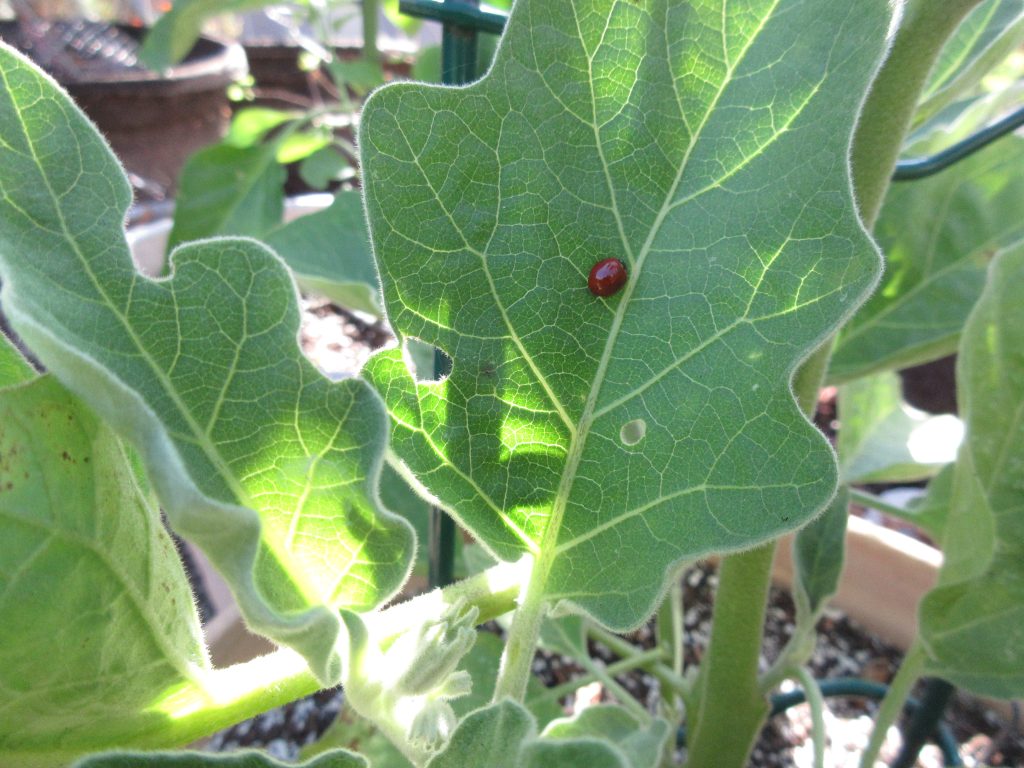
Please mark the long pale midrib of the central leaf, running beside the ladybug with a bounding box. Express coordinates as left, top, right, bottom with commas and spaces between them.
530, 0, 780, 583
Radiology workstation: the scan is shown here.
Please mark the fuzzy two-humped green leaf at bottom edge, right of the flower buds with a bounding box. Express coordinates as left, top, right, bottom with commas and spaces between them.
427, 699, 630, 768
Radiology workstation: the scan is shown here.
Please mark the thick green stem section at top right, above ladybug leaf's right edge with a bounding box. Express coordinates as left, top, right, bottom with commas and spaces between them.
852, 0, 981, 231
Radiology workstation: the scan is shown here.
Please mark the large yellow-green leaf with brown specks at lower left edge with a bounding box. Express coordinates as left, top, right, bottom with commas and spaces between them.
0, 376, 209, 766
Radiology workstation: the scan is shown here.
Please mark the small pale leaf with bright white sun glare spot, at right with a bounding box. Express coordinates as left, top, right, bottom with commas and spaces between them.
837, 372, 964, 483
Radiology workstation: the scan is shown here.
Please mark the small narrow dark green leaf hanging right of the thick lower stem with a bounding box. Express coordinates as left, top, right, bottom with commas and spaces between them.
793, 485, 850, 626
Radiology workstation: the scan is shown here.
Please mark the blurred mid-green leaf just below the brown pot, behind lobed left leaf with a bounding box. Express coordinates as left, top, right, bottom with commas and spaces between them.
167, 141, 286, 253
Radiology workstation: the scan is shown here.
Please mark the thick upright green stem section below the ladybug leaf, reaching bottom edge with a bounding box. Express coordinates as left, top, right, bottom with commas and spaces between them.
686, 543, 775, 768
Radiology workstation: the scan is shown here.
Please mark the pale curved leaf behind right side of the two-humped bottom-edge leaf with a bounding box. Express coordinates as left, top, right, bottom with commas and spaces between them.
541, 705, 672, 768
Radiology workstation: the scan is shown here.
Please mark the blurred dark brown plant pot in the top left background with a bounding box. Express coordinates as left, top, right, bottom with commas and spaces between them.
0, 20, 248, 201
